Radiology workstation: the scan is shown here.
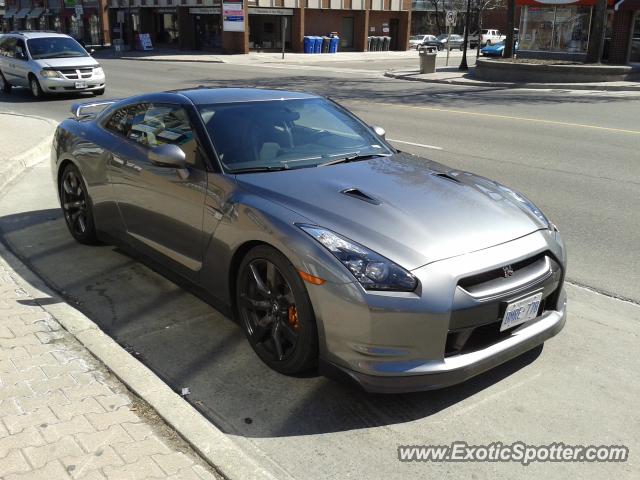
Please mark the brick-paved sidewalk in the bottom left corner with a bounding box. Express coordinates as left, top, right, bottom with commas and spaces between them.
0, 246, 220, 480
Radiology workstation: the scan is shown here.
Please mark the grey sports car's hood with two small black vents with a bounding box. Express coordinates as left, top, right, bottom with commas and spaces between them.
236, 153, 547, 269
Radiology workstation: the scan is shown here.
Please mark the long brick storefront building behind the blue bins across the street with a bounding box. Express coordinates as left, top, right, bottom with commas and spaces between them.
109, 0, 411, 53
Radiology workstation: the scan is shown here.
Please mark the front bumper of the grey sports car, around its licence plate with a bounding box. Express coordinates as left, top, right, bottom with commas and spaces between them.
308, 230, 566, 392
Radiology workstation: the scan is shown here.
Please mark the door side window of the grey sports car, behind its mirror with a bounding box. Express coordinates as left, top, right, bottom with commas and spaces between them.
127, 104, 200, 165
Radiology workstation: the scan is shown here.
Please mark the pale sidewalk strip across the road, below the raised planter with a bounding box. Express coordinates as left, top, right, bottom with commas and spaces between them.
384, 66, 640, 92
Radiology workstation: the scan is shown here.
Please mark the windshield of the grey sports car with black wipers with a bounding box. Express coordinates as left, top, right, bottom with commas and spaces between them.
198, 98, 393, 172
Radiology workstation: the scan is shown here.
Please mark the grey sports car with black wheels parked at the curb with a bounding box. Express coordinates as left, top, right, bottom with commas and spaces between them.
51, 88, 566, 392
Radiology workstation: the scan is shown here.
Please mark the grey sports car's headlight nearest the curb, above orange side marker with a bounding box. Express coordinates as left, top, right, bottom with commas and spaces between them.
298, 225, 418, 292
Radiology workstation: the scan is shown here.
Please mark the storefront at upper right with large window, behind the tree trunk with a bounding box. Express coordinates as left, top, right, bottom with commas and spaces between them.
517, 0, 640, 64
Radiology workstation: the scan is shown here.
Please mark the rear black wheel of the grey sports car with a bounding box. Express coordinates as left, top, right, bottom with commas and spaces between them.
58, 163, 99, 245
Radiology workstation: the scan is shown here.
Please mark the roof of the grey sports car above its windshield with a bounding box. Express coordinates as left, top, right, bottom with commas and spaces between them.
172, 88, 319, 105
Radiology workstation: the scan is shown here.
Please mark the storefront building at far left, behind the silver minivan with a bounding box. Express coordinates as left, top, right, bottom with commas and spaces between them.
1, 0, 110, 46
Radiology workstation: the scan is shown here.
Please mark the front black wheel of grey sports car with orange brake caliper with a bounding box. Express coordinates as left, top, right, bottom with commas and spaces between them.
235, 245, 318, 375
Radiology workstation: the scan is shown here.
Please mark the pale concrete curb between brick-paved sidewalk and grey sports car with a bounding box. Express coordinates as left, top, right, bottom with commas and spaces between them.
0, 113, 284, 480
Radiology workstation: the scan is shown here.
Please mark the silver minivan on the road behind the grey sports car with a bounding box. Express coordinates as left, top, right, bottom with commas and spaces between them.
0, 32, 105, 98
